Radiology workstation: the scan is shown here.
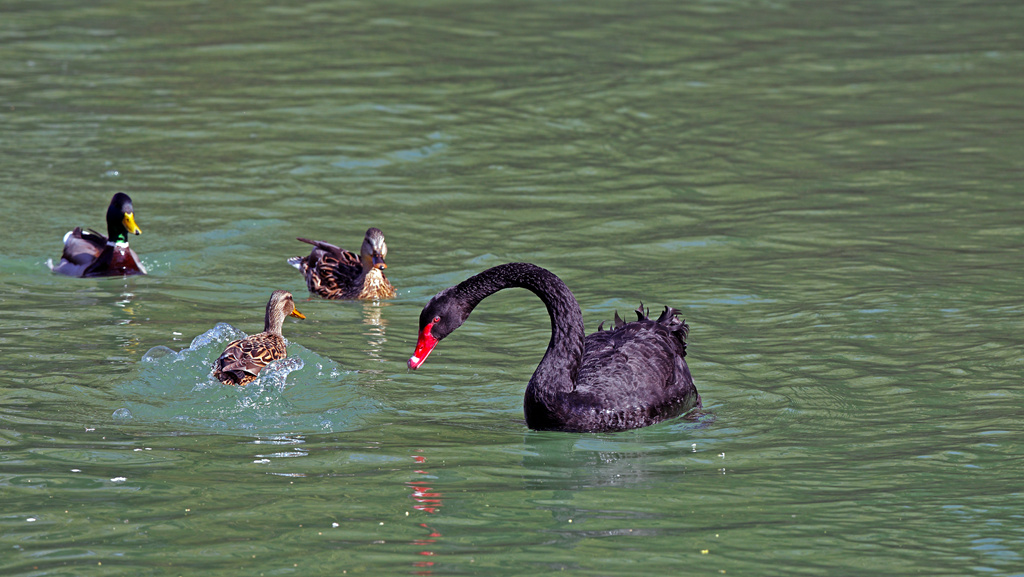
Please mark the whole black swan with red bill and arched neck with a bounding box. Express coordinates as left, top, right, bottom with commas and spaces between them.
409, 262, 700, 432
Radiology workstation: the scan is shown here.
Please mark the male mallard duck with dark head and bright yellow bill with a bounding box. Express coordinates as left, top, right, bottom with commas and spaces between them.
46, 193, 145, 277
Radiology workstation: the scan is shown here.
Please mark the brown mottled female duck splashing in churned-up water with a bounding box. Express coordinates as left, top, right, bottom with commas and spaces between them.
213, 290, 305, 386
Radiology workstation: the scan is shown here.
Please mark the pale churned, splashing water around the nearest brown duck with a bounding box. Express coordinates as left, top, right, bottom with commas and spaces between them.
111, 323, 378, 435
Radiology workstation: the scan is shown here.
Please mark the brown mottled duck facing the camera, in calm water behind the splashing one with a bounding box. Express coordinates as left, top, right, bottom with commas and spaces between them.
288, 229, 394, 300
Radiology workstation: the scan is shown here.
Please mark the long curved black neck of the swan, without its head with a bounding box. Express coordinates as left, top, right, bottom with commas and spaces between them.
457, 262, 584, 395
